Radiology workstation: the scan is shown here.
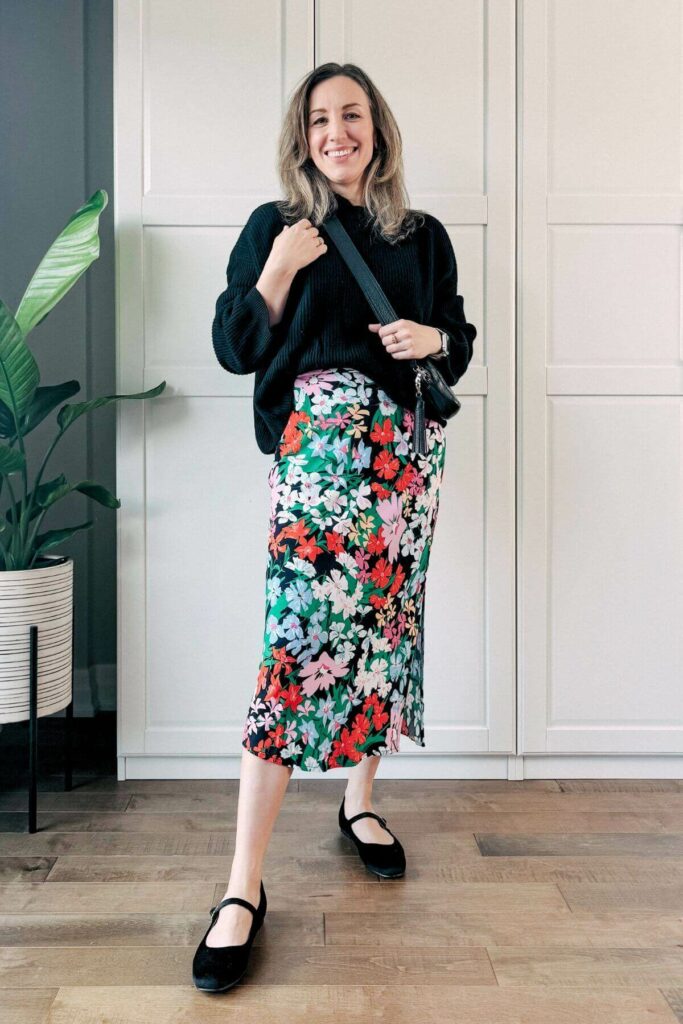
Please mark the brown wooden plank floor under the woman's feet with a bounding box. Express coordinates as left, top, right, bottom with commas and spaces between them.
0, 716, 683, 1024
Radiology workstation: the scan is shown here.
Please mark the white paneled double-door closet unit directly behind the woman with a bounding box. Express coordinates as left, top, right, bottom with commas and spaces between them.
115, 0, 516, 778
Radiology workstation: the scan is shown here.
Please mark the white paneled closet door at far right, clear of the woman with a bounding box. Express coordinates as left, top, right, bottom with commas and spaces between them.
519, 0, 683, 761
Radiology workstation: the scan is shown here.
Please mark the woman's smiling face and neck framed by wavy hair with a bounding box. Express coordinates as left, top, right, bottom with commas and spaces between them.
307, 75, 375, 204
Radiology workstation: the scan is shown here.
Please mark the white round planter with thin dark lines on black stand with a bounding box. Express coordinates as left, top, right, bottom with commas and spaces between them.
0, 555, 74, 723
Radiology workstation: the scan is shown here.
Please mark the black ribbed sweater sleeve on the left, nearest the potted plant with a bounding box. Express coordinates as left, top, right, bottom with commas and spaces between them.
212, 211, 283, 374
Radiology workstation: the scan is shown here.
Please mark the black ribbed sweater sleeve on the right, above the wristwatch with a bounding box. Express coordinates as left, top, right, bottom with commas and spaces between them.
429, 218, 477, 387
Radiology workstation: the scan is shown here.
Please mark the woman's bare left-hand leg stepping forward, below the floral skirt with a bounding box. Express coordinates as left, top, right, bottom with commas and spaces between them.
206, 746, 294, 946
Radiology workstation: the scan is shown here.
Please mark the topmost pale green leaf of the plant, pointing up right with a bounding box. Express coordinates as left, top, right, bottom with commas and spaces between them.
16, 188, 109, 338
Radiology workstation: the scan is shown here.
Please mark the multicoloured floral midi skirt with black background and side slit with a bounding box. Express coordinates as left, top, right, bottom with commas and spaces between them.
242, 368, 445, 772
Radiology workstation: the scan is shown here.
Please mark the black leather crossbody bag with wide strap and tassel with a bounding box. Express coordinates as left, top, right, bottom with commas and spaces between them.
321, 214, 461, 455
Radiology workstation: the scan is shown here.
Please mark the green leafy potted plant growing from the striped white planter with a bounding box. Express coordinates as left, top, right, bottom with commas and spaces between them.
0, 188, 166, 571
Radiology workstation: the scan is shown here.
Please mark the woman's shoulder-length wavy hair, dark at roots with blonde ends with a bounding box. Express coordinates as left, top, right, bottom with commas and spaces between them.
276, 61, 424, 244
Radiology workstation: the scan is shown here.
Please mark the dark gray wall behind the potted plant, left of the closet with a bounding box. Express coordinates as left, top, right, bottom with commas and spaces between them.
0, 0, 117, 714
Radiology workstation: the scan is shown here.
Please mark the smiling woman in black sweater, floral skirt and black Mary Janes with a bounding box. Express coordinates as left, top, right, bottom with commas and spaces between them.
194, 63, 476, 991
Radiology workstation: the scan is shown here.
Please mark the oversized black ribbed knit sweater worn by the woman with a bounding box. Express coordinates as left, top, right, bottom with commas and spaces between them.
212, 194, 477, 454
